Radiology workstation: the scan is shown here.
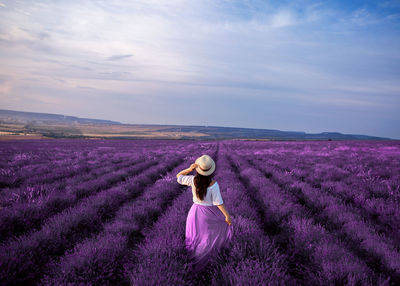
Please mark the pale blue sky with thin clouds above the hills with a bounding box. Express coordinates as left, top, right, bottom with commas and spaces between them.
0, 0, 400, 139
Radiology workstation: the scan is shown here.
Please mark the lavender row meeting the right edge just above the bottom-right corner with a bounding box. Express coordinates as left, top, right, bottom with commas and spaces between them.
244, 155, 400, 281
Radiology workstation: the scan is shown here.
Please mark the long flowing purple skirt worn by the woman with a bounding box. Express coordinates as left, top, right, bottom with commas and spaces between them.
185, 203, 233, 272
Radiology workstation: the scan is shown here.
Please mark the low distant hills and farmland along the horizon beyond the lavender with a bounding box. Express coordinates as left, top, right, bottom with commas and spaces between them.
0, 109, 392, 140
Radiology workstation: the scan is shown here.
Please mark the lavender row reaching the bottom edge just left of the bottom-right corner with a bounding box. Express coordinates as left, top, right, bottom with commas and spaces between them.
227, 151, 386, 285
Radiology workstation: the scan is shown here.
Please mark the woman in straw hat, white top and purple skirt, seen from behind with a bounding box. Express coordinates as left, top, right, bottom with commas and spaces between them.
176, 155, 233, 272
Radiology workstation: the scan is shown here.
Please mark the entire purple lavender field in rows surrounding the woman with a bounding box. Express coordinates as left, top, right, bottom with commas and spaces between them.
0, 139, 400, 285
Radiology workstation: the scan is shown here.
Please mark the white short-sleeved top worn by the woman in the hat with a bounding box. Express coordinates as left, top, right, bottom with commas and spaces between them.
177, 175, 224, 206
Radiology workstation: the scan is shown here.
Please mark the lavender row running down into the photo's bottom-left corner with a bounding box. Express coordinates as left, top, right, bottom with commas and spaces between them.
0, 153, 182, 285
